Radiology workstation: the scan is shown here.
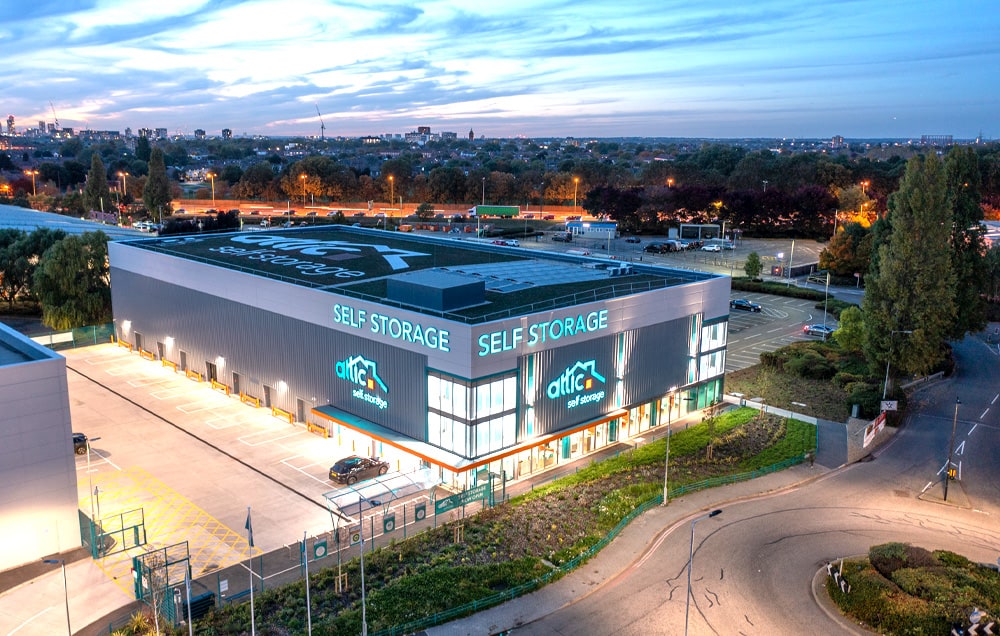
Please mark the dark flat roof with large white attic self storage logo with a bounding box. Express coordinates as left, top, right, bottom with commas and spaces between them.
128, 225, 720, 323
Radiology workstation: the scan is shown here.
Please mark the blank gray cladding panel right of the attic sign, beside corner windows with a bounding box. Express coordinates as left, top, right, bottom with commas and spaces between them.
622, 317, 692, 408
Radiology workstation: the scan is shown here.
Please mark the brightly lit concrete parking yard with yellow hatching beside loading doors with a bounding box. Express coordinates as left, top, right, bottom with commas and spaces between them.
64, 344, 364, 593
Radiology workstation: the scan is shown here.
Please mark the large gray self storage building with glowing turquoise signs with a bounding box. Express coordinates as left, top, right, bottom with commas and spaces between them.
108, 226, 730, 486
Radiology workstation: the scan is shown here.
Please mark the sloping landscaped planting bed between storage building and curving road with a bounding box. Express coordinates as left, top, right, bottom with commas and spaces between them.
188, 409, 815, 635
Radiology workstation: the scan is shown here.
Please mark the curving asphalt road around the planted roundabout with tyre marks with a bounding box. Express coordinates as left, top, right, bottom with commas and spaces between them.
515, 330, 1000, 636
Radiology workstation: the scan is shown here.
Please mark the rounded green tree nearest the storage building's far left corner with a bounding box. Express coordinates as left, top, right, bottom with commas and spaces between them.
32, 231, 111, 330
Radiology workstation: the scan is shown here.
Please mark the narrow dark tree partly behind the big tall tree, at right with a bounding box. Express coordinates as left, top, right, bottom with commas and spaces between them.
944, 146, 986, 339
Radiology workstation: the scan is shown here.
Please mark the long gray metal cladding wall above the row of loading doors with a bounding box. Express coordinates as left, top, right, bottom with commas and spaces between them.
111, 269, 427, 440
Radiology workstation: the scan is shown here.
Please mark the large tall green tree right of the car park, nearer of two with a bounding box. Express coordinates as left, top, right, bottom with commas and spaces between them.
863, 154, 956, 373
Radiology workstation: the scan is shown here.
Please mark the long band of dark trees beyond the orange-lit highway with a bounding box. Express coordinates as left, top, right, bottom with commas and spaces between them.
5, 138, 1000, 238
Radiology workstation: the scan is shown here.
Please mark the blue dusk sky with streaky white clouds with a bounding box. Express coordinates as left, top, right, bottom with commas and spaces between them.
0, 0, 1000, 139
